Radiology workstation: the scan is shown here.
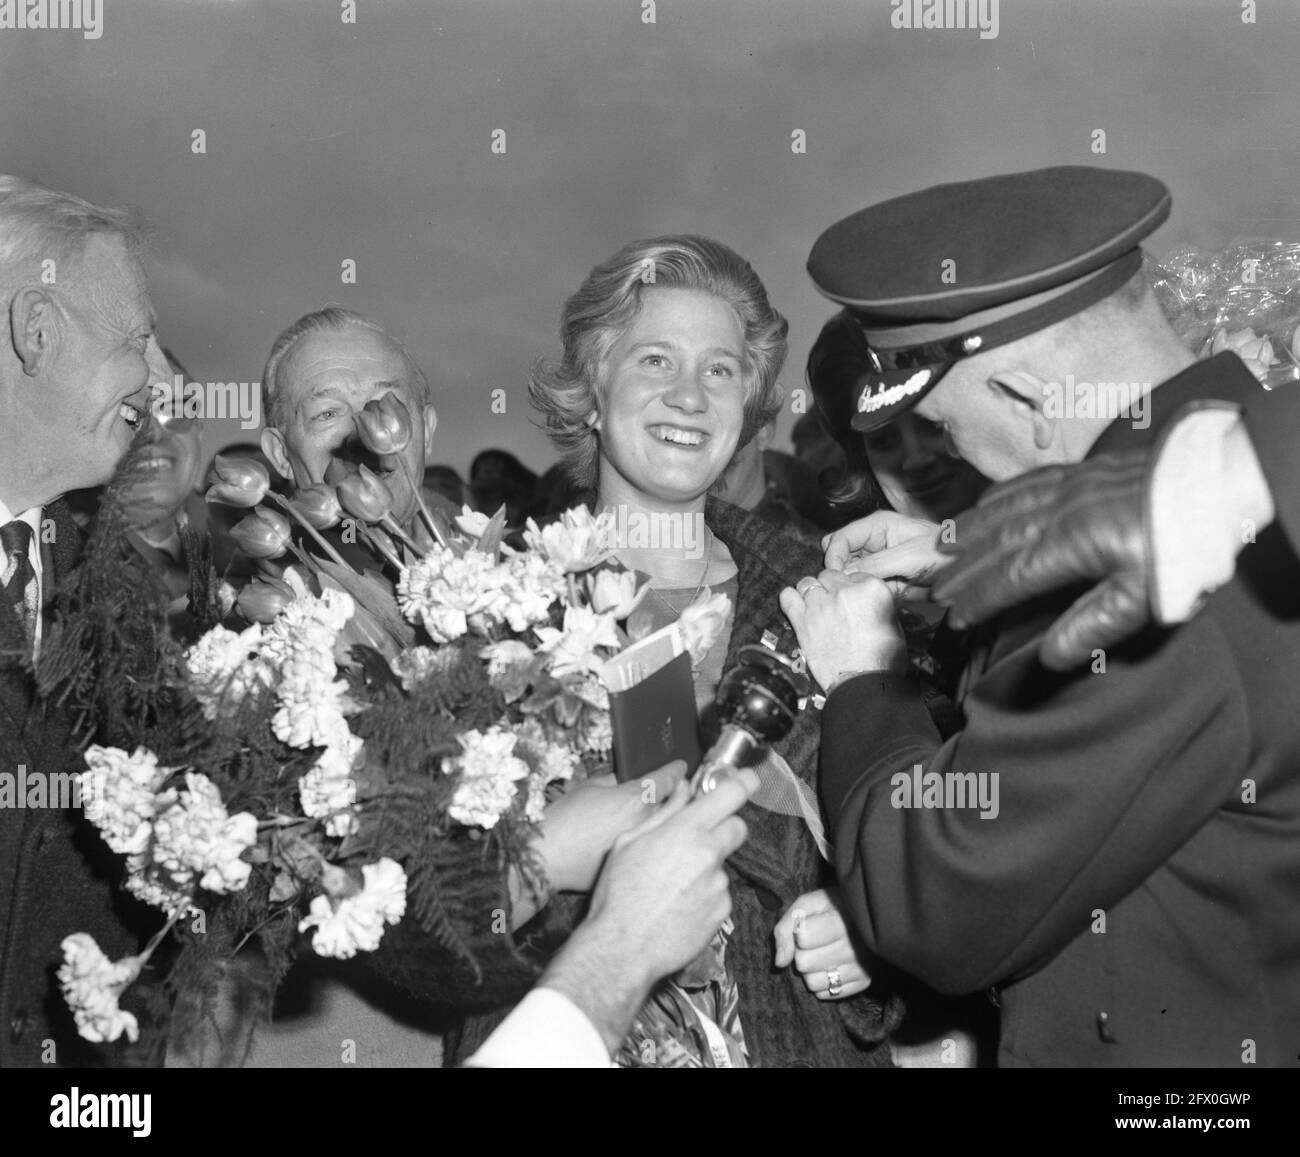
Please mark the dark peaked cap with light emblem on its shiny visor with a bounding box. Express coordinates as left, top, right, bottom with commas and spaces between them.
807, 165, 1170, 430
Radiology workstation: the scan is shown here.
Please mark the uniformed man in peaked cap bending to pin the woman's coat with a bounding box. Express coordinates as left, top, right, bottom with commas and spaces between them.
781, 168, 1300, 1066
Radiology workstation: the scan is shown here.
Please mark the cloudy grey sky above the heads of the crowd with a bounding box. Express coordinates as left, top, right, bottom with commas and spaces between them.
0, 0, 1300, 471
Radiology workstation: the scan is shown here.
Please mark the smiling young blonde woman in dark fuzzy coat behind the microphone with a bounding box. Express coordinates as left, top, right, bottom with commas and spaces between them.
447, 237, 898, 1067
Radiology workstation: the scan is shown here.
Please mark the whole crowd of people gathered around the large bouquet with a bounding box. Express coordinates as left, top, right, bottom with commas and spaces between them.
0, 168, 1300, 1067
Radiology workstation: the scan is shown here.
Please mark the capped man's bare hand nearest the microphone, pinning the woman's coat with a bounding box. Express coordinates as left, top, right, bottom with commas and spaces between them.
780, 571, 907, 694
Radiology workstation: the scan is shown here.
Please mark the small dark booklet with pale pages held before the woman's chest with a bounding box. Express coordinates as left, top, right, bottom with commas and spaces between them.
602, 623, 703, 783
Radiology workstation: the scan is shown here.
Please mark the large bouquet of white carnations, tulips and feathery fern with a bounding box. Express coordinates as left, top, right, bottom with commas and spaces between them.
42, 395, 733, 1041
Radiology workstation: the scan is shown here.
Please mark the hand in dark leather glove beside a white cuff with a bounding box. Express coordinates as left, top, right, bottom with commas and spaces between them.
932, 451, 1153, 671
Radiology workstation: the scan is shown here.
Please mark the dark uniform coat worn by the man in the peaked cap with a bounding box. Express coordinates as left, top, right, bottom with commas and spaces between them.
820, 354, 1300, 1069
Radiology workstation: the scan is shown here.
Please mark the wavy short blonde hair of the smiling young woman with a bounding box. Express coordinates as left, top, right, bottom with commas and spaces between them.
528, 235, 789, 489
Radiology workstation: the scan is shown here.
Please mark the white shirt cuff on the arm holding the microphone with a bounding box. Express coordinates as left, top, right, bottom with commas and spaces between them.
465, 988, 612, 1069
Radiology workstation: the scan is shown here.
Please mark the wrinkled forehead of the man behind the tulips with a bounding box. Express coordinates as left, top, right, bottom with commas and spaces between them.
276, 326, 419, 404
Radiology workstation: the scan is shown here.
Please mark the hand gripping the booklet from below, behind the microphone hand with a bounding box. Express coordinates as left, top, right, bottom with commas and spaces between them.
534, 759, 686, 892
